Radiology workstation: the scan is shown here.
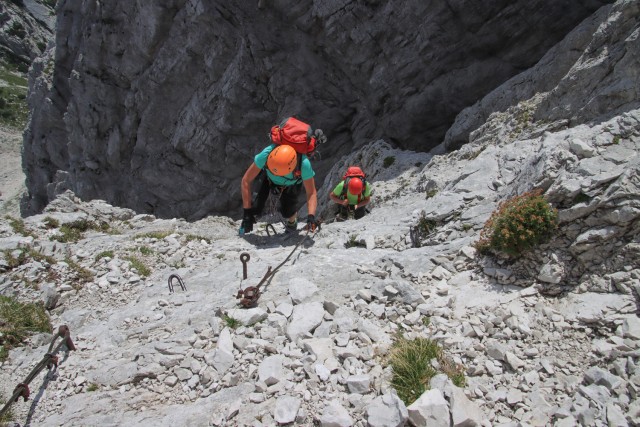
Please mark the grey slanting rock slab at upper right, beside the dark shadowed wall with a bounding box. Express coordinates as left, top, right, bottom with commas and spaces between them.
445, 1, 640, 149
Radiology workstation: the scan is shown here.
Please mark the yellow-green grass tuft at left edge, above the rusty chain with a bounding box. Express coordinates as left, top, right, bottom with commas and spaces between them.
0, 295, 51, 361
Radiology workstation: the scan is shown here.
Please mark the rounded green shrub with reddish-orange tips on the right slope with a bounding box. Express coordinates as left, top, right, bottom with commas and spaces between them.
474, 190, 558, 256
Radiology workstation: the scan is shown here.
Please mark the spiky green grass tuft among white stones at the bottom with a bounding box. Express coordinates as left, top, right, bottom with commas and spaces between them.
388, 336, 465, 406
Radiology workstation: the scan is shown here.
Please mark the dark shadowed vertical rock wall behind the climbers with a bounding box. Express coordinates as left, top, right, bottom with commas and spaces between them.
23, 0, 609, 219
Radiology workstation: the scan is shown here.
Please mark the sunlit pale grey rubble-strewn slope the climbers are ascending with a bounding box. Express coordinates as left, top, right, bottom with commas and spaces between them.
0, 1, 640, 427
